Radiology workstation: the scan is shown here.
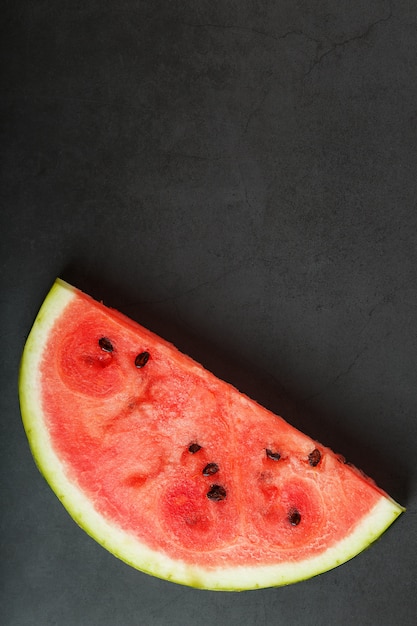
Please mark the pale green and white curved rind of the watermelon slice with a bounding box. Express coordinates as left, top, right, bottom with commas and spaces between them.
19, 279, 404, 591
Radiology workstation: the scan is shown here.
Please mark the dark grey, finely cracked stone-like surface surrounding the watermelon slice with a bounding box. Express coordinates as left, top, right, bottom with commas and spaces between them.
0, 0, 417, 626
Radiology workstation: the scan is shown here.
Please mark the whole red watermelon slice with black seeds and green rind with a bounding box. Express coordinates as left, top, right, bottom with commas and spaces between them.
19, 279, 404, 590
